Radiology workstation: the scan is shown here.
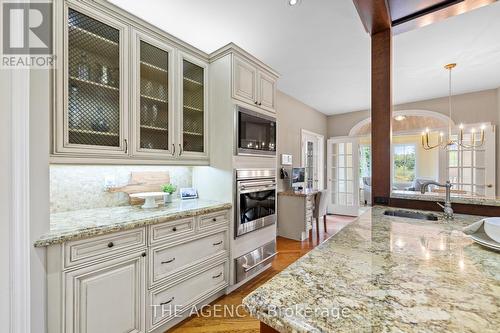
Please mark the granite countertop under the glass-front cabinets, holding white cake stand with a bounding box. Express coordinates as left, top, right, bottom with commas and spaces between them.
34, 199, 232, 247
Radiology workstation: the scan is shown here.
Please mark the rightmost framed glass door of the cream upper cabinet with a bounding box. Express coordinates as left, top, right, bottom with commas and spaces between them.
179, 54, 207, 157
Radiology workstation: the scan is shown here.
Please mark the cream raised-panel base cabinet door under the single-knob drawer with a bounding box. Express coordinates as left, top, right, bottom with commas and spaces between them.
65, 252, 145, 333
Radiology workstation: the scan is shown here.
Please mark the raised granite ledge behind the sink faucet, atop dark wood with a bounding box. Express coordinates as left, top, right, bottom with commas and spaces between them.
391, 191, 500, 206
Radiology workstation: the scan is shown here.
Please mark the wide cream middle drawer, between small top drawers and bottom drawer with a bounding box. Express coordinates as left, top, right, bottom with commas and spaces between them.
150, 232, 227, 285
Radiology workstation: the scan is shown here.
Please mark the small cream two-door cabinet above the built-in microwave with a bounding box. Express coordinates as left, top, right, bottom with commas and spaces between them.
232, 54, 276, 112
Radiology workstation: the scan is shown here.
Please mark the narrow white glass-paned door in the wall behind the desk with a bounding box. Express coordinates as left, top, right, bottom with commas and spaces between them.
301, 130, 325, 190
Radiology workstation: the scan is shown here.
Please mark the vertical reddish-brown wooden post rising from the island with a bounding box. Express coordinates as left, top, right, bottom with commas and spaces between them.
371, 28, 392, 205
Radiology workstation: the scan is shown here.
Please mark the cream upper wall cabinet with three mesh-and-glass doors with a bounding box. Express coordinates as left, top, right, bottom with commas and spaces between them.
51, 0, 209, 165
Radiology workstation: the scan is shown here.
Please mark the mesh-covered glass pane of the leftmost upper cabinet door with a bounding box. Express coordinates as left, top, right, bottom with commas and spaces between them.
68, 9, 120, 147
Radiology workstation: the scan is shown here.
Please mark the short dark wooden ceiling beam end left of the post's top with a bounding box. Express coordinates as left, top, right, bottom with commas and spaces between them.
353, 0, 392, 35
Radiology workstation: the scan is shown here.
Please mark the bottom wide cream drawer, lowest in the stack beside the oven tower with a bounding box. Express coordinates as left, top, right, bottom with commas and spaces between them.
148, 261, 227, 330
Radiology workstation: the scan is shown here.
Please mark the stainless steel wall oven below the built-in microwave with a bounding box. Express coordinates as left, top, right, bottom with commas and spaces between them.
234, 169, 276, 237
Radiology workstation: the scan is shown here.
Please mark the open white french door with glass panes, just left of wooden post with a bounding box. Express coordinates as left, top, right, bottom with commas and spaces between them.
327, 137, 359, 216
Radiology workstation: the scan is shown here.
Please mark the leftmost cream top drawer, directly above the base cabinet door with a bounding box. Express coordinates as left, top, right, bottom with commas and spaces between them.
64, 228, 146, 267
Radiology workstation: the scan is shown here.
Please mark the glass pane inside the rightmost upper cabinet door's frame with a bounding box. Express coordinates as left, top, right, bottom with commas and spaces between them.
182, 60, 205, 153
